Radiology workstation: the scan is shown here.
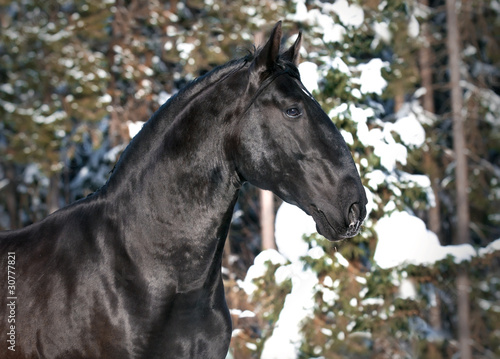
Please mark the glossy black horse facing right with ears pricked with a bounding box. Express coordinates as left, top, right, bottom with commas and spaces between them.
0, 23, 366, 359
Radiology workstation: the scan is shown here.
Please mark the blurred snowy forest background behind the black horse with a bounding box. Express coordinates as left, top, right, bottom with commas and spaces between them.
0, 0, 500, 358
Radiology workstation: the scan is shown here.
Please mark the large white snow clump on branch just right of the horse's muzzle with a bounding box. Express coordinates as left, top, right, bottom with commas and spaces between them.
373, 211, 484, 269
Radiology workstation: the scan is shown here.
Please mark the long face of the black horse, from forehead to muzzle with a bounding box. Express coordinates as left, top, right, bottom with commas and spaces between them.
231, 23, 367, 240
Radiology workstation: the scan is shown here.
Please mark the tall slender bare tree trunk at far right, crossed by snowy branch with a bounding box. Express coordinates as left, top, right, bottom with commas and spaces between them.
446, 0, 472, 359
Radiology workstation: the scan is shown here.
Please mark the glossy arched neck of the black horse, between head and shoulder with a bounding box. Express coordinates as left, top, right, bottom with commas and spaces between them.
105, 70, 248, 288
